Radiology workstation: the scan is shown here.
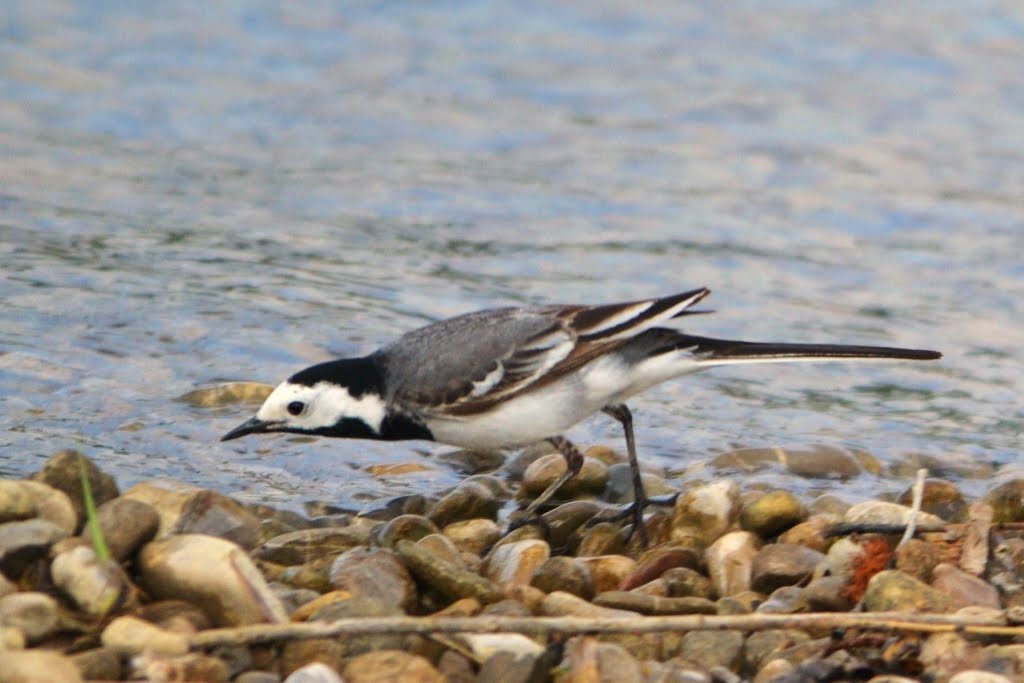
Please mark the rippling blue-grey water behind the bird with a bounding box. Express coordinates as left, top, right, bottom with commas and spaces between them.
0, 0, 1024, 508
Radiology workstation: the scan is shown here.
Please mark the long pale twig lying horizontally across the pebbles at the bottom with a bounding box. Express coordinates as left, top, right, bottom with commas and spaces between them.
189, 612, 1024, 649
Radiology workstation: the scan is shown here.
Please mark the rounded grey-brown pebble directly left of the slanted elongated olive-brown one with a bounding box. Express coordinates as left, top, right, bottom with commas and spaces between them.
329, 541, 417, 611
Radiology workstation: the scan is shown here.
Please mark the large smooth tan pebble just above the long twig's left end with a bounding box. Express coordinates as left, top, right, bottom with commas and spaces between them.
138, 533, 288, 626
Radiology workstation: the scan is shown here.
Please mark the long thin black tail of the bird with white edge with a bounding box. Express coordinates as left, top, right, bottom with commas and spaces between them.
673, 334, 942, 362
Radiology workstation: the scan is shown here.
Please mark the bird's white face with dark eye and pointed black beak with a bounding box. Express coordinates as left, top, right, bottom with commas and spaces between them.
225, 381, 385, 439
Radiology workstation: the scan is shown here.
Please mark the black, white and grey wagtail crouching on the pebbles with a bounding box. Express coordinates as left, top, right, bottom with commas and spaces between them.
221, 288, 942, 545
